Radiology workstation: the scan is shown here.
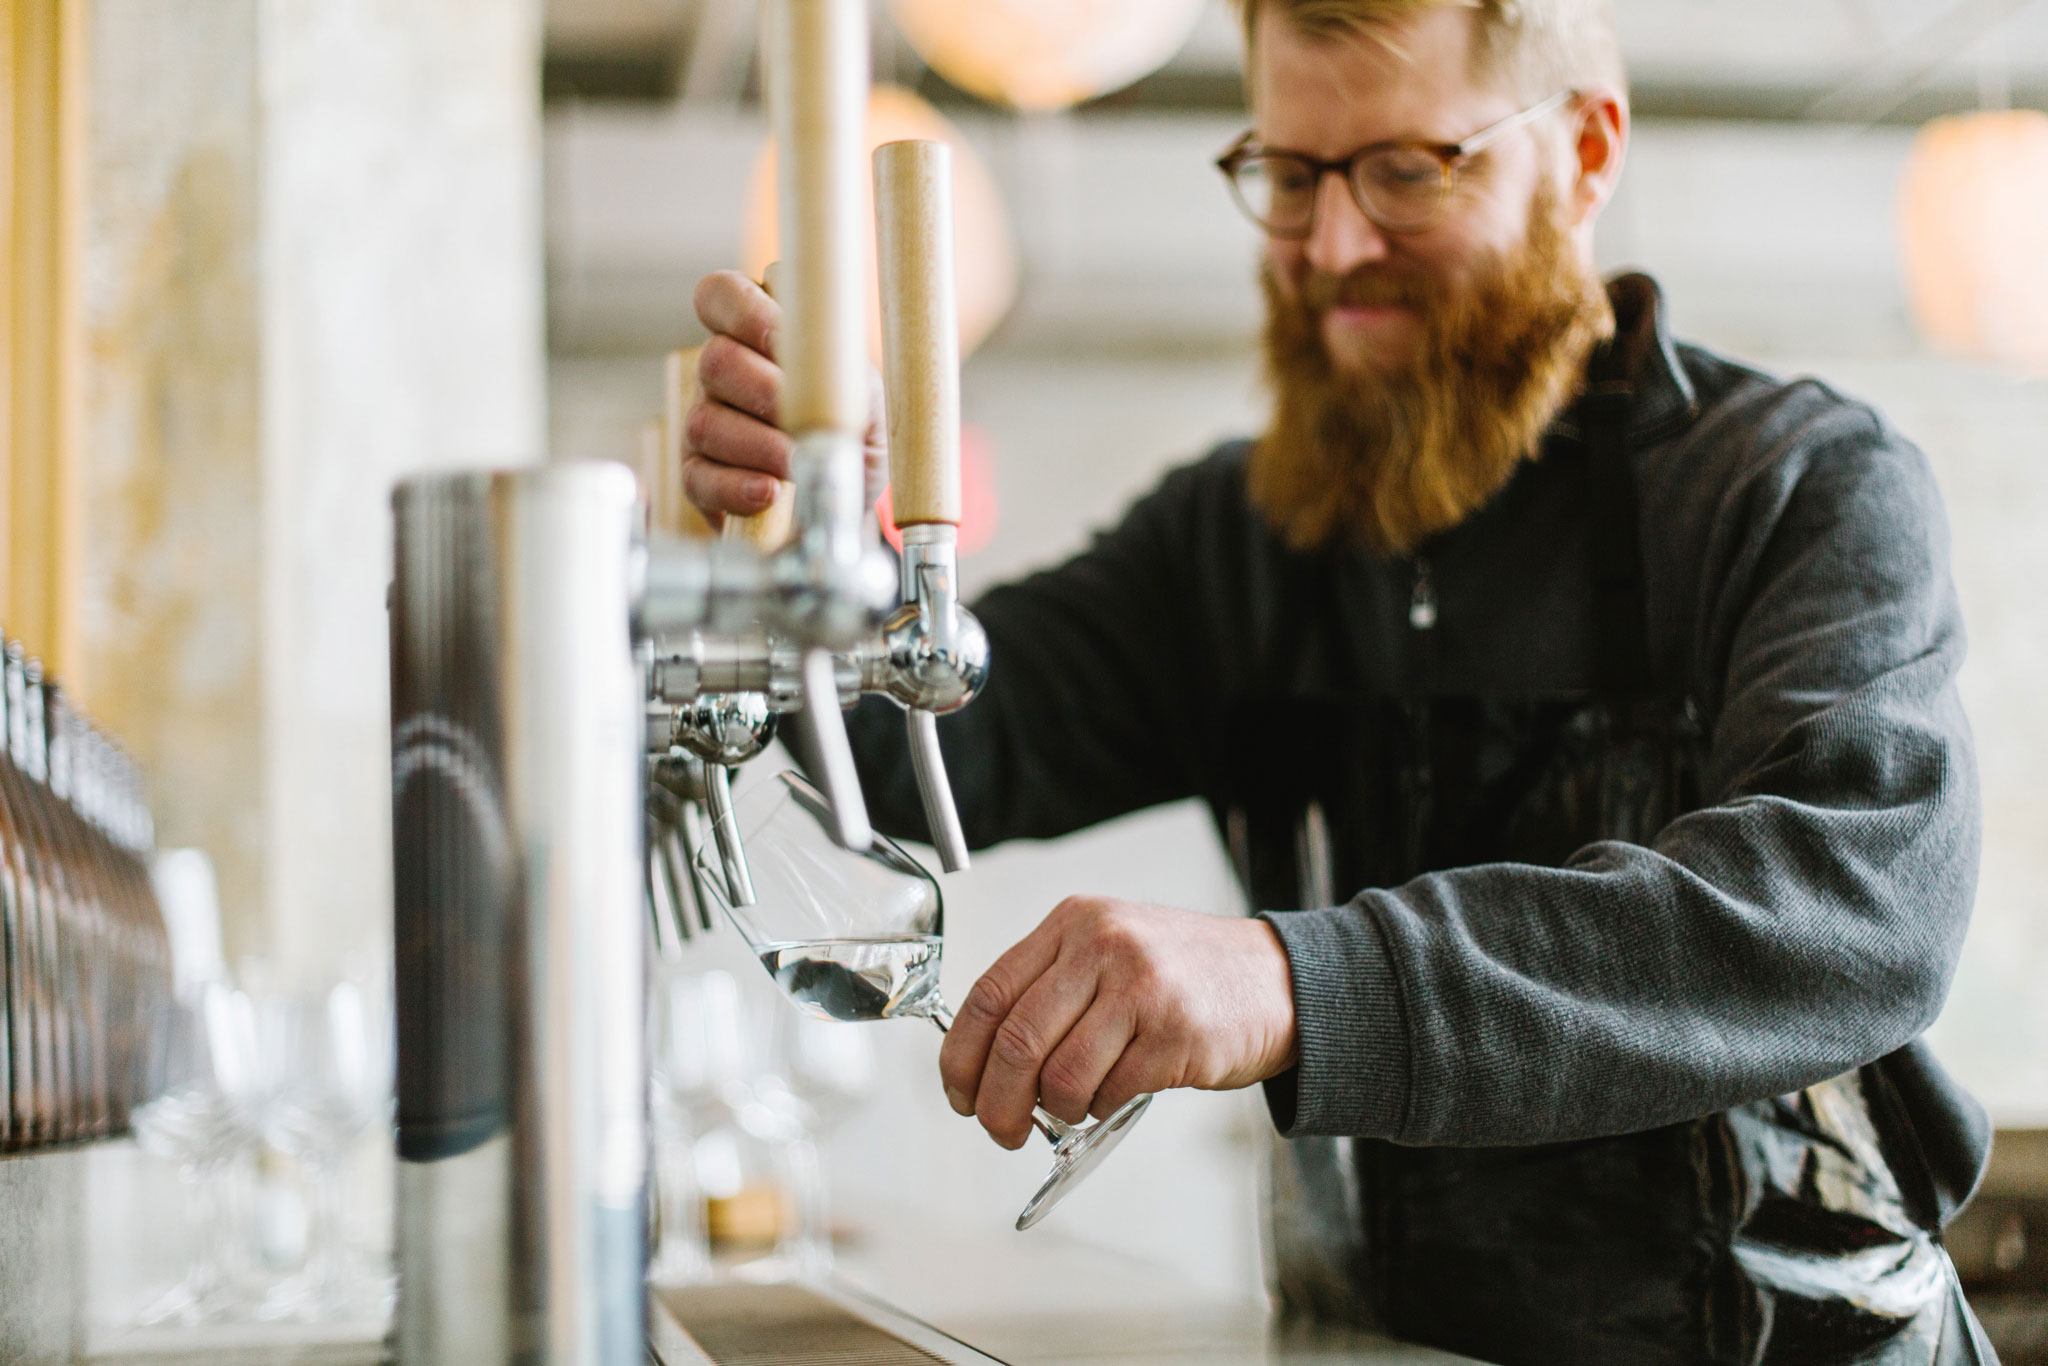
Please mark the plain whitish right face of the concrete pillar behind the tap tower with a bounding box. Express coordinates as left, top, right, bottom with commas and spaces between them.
260, 0, 547, 971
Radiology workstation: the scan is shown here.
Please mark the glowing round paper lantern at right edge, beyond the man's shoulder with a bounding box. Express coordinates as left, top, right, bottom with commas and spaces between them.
1898, 109, 2048, 375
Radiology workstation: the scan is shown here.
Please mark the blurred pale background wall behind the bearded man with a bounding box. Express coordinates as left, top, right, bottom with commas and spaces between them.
547, 0, 2048, 1310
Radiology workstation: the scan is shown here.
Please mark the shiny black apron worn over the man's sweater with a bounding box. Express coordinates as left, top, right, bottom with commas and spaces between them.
1214, 385, 1997, 1366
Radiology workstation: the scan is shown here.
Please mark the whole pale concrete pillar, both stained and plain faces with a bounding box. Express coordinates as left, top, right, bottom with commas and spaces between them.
84, 0, 545, 973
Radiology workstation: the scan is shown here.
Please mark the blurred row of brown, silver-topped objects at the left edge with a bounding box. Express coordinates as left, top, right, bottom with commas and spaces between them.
0, 641, 172, 1151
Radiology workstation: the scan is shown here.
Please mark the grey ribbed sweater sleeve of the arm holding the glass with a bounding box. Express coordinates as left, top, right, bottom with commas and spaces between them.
1268, 414, 1978, 1145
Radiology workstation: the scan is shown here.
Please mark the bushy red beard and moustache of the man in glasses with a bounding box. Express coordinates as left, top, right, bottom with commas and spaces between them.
1247, 195, 1614, 555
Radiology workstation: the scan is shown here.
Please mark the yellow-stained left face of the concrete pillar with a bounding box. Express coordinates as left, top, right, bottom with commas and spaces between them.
80, 0, 268, 970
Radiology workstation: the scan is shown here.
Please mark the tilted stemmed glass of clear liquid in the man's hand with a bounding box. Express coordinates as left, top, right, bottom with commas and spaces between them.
698, 772, 1151, 1231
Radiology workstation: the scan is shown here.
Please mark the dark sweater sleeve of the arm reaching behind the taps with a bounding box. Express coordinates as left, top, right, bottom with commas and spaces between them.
850, 465, 1204, 848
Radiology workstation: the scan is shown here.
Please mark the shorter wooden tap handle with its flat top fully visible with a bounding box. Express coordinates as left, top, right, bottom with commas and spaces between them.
874, 141, 961, 526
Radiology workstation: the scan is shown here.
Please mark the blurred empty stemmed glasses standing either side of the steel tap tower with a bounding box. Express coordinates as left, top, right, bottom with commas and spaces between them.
135, 967, 877, 1323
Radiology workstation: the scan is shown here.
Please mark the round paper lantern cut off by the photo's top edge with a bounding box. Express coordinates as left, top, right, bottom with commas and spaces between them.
891, 0, 1202, 109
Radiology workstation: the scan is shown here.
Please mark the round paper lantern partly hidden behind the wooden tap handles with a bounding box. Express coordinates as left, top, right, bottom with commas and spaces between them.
739, 86, 1018, 356
